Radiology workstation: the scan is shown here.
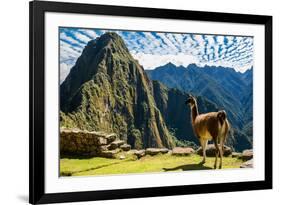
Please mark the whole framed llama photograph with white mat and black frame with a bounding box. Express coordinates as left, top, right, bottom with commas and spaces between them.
30, 1, 272, 204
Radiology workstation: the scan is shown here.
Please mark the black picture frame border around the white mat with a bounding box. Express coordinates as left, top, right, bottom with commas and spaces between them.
29, 1, 272, 204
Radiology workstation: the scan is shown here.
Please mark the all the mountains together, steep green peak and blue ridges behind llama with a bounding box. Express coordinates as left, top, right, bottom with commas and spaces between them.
60, 32, 252, 150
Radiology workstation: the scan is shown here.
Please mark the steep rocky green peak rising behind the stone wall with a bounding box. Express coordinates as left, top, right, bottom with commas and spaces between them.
60, 32, 173, 149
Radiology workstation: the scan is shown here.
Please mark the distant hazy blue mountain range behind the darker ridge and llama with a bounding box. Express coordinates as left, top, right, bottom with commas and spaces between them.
146, 63, 253, 150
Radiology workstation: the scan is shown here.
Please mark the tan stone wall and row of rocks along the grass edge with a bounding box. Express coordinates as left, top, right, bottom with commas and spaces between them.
60, 128, 253, 168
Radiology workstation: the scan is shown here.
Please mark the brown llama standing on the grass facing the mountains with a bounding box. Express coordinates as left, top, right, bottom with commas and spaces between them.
186, 95, 230, 169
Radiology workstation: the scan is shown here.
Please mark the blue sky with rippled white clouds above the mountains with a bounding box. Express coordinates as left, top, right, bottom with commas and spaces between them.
59, 28, 254, 82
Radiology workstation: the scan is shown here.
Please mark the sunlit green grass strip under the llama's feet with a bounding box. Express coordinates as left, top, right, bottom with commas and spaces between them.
60, 154, 243, 176
